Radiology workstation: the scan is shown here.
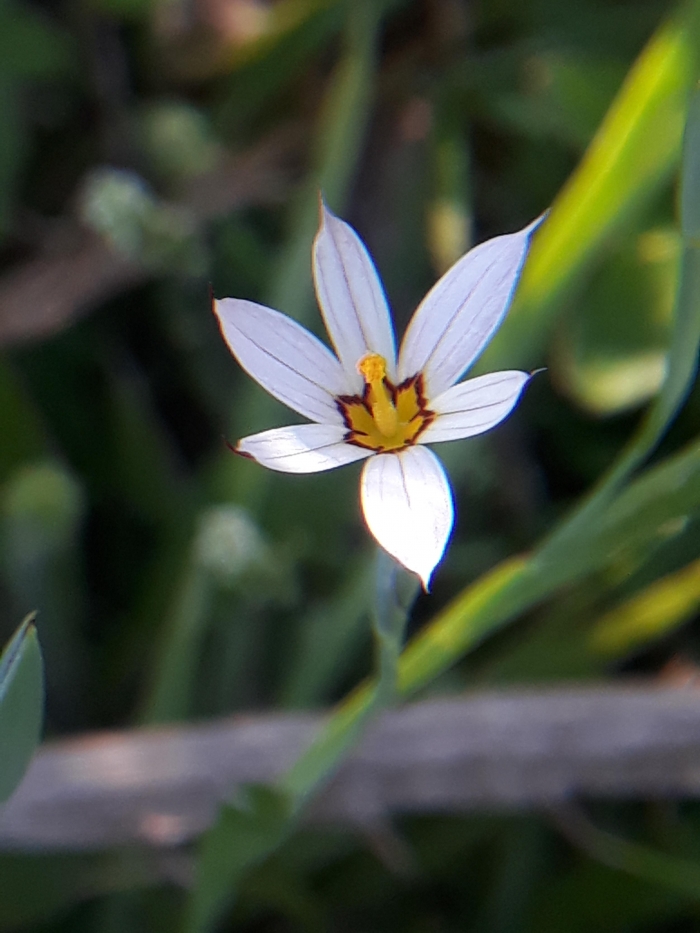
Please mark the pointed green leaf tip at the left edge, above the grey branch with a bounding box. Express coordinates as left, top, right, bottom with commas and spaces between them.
0, 615, 44, 802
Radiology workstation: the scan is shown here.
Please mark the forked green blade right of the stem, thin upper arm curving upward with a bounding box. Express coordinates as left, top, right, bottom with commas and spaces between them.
402, 74, 700, 691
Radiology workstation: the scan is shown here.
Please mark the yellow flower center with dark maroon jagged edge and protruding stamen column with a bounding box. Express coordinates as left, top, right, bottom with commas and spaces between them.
337, 353, 435, 453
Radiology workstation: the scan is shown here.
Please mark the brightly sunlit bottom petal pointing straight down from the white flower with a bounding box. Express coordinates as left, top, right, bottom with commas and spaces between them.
361, 447, 454, 590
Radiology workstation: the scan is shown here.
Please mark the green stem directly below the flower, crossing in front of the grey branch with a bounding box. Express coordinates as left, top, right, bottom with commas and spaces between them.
279, 549, 418, 812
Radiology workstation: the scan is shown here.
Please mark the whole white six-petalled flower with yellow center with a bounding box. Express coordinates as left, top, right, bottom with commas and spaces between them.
214, 204, 539, 589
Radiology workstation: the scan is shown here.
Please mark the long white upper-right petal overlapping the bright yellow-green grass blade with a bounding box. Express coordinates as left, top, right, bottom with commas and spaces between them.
399, 218, 541, 398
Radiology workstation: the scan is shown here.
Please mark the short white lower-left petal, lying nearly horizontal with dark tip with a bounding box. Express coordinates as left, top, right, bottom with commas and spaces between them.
236, 424, 372, 473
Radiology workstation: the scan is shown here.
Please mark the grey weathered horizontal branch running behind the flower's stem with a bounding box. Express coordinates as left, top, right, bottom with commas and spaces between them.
0, 684, 700, 850
